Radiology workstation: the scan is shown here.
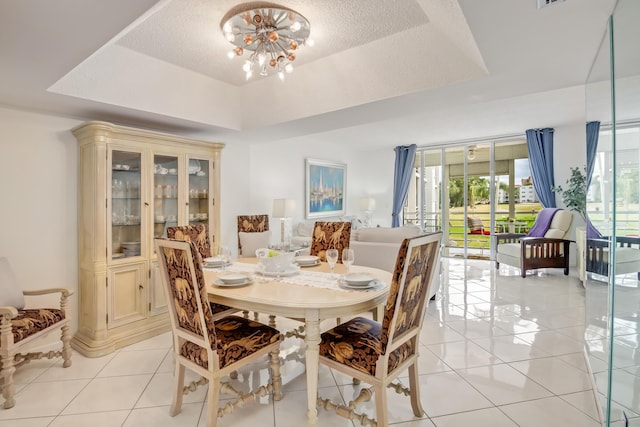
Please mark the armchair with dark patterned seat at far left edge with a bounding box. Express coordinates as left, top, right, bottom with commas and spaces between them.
0, 258, 73, 409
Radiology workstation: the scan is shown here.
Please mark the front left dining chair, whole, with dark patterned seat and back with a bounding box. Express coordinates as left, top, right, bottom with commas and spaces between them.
155, 238, 282, 427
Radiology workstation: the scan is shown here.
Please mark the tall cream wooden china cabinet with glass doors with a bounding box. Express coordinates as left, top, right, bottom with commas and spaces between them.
72, 121, 224, 357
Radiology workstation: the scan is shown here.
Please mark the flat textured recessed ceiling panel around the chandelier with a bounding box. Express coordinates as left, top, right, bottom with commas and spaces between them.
117, 0, 428, 86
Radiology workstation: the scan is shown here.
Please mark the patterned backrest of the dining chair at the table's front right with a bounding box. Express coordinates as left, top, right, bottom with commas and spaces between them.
380, 231, 442, 354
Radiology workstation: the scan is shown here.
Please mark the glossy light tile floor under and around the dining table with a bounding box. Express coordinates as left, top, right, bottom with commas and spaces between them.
0, 259, 601, 427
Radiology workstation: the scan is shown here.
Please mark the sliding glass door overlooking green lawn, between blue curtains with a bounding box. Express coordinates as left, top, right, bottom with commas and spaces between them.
404, 138, 541, 259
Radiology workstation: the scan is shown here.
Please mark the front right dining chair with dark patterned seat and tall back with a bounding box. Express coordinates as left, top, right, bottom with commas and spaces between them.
319, 232, 442, 426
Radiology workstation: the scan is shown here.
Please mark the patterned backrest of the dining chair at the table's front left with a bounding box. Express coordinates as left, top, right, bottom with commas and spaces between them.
155, 237, 218, 367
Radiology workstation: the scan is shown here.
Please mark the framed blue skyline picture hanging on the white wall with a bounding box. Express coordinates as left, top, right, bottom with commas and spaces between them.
305, 159, 347, 219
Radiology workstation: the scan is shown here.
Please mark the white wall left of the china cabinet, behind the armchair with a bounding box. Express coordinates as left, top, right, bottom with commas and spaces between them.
0, 108, 78, 330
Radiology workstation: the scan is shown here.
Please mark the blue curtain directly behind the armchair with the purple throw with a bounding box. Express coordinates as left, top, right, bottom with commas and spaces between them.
526, 128, 556, 208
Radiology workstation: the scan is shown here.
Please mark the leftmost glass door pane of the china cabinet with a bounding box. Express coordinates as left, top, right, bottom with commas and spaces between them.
111, 150, 142, 260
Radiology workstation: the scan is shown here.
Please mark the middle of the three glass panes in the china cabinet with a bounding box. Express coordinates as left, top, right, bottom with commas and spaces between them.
153, 155, 178, 241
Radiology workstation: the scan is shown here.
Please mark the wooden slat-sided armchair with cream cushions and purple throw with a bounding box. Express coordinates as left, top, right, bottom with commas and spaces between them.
495, 208, 573, 277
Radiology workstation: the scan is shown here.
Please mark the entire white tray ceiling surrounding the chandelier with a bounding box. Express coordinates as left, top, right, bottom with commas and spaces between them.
0, 0, 615, 149
